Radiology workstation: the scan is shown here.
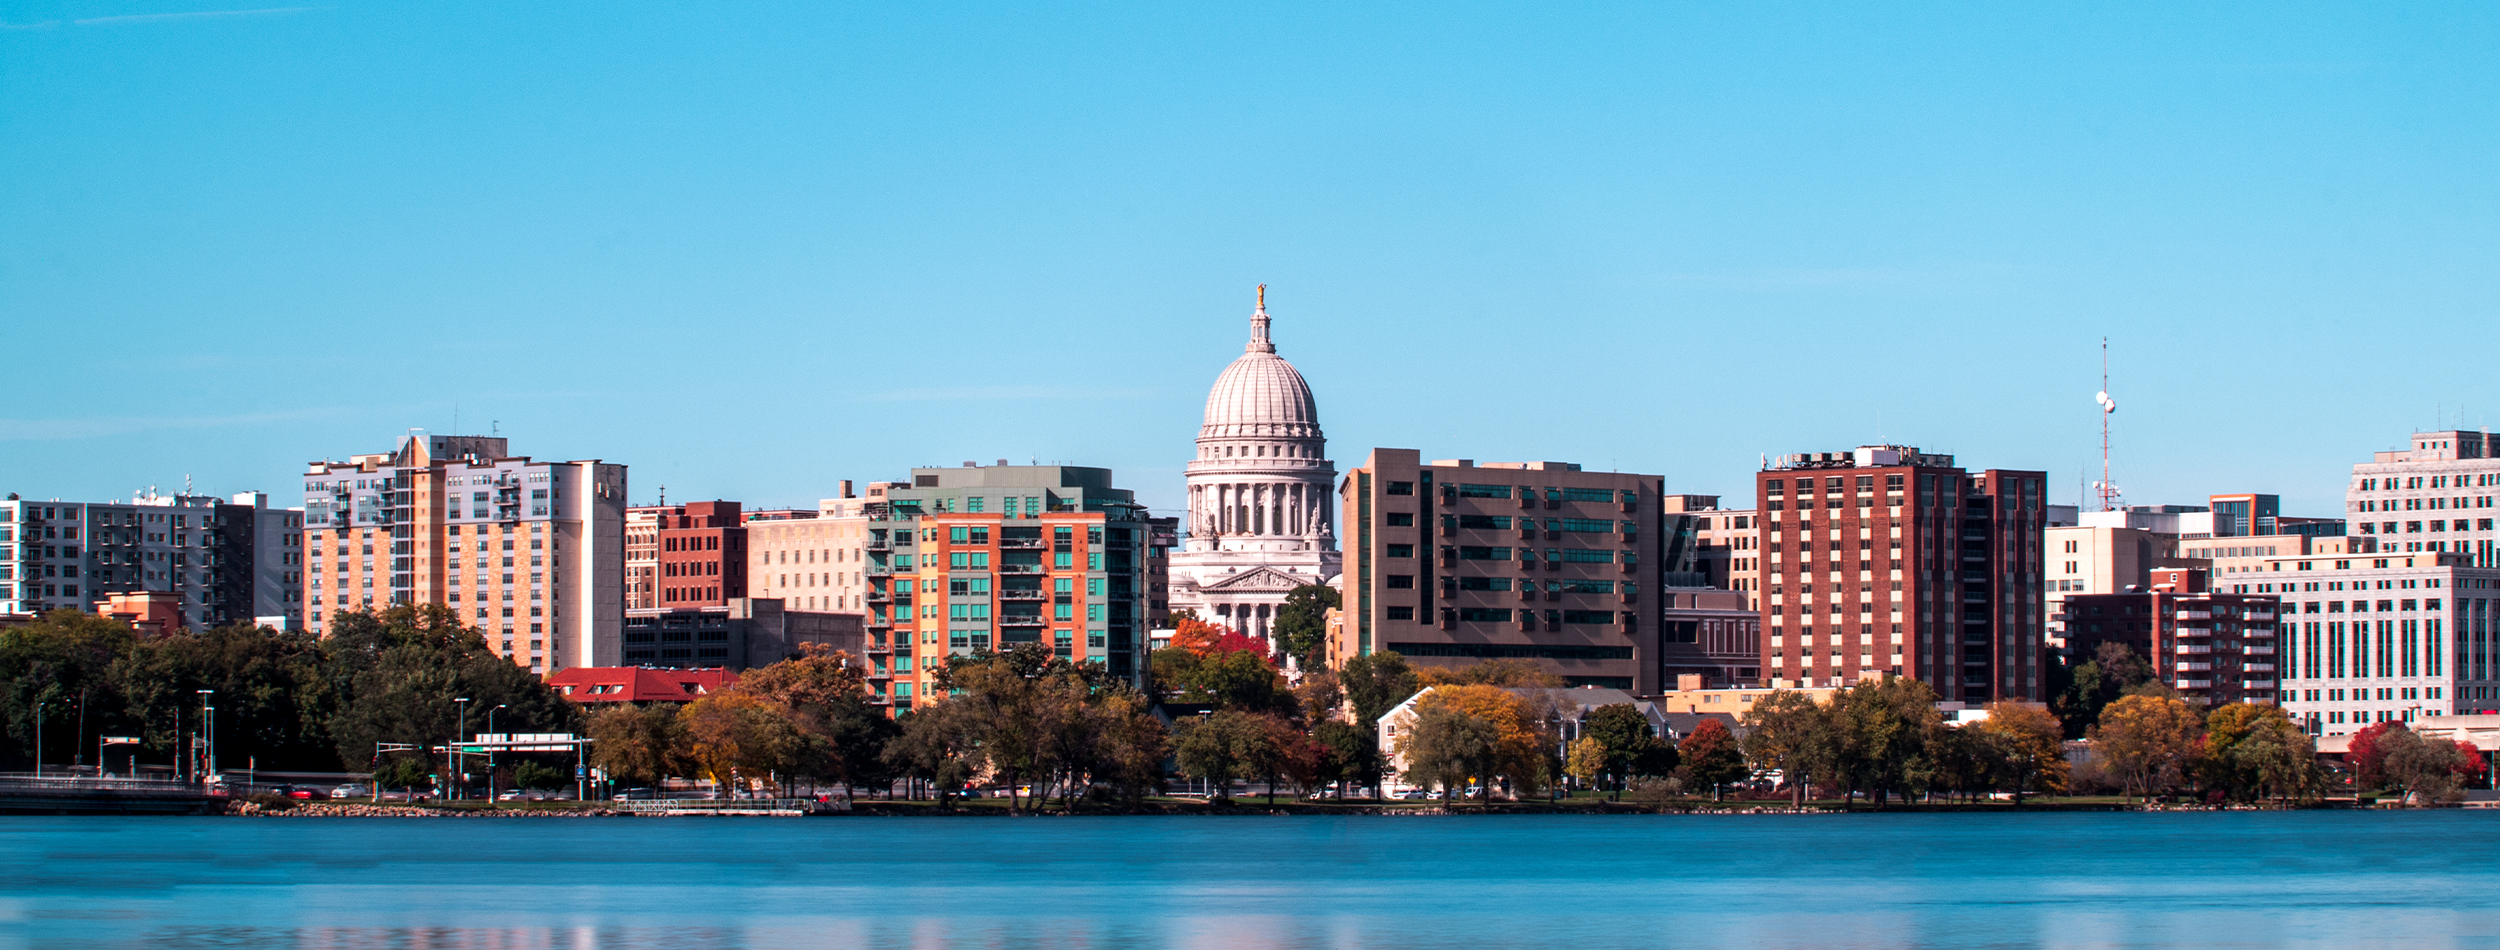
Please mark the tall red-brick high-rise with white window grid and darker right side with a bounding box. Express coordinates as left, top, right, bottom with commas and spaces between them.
1755, 445, 2048, 703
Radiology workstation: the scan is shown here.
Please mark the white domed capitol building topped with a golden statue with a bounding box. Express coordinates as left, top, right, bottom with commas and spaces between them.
1173, 288, 1340, 640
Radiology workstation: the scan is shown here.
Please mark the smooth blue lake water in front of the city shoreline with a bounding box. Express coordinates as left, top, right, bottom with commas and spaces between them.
0, 810, 2500, 950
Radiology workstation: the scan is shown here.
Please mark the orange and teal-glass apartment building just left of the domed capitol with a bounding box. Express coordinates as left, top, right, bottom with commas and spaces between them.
845, 463, 1160, 708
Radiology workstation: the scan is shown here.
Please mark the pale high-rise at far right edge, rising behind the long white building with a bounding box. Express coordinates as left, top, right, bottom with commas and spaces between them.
2345, 430, 2500, 568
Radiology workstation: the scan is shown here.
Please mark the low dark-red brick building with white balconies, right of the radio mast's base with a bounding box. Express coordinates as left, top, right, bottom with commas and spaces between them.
2065, 568, 2283, 708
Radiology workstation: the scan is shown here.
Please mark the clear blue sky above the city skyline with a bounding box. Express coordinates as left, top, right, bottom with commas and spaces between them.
0, 0, 2500, 515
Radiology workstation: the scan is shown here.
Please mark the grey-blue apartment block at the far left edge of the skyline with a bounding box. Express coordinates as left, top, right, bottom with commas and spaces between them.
0, 490, 303, 630
